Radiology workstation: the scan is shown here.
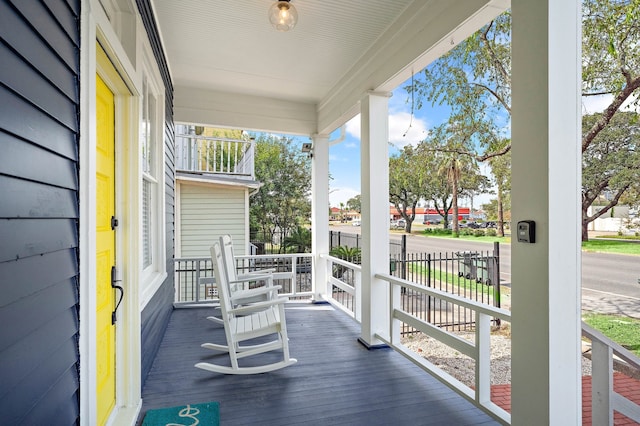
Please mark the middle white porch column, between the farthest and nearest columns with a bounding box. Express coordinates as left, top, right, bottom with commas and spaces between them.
360, 92, 390, 347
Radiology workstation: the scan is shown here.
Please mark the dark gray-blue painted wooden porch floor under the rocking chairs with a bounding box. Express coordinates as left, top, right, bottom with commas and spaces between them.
139, 303, 498, 426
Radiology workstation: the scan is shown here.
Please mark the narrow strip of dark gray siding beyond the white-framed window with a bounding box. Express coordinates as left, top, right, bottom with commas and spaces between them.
136, 0, 175, 386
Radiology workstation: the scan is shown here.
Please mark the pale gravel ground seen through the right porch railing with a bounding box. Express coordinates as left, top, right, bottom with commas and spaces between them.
402, 332, 591, 387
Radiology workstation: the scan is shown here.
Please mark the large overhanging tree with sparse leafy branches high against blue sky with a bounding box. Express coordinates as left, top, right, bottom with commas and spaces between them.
407, 0, 640, 240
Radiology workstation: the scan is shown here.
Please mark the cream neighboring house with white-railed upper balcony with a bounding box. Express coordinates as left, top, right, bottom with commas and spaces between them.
175, 124, 260, 258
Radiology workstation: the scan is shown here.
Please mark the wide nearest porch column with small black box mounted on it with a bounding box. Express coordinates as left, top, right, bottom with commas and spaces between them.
511, 0, 582, 425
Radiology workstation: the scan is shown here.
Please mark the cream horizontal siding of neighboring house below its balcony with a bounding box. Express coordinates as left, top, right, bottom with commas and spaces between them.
178, 182, 249, 257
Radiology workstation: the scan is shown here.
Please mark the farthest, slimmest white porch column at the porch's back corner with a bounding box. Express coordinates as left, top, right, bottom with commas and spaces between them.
311, 135, 329, 301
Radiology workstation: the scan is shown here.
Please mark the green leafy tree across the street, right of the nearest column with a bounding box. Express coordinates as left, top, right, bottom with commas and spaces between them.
582, 112, 640, 241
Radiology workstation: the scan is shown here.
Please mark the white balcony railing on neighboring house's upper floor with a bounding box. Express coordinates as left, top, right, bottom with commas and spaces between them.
176, 135, 255, 179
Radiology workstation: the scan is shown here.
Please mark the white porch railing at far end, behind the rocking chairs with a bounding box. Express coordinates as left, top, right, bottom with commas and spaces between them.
174, 253, 313, 306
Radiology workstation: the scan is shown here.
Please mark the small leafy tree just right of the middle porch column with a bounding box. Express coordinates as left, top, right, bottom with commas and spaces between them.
389, 145, 427, 233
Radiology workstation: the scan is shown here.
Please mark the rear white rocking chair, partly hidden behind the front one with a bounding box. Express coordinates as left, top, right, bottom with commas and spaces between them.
207, 235, 282, 324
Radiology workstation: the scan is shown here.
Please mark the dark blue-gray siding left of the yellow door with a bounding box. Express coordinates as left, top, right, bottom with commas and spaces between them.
0, 0, 80, 425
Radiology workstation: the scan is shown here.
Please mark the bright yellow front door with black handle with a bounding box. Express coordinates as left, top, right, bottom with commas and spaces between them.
96, 75, 116, 425
